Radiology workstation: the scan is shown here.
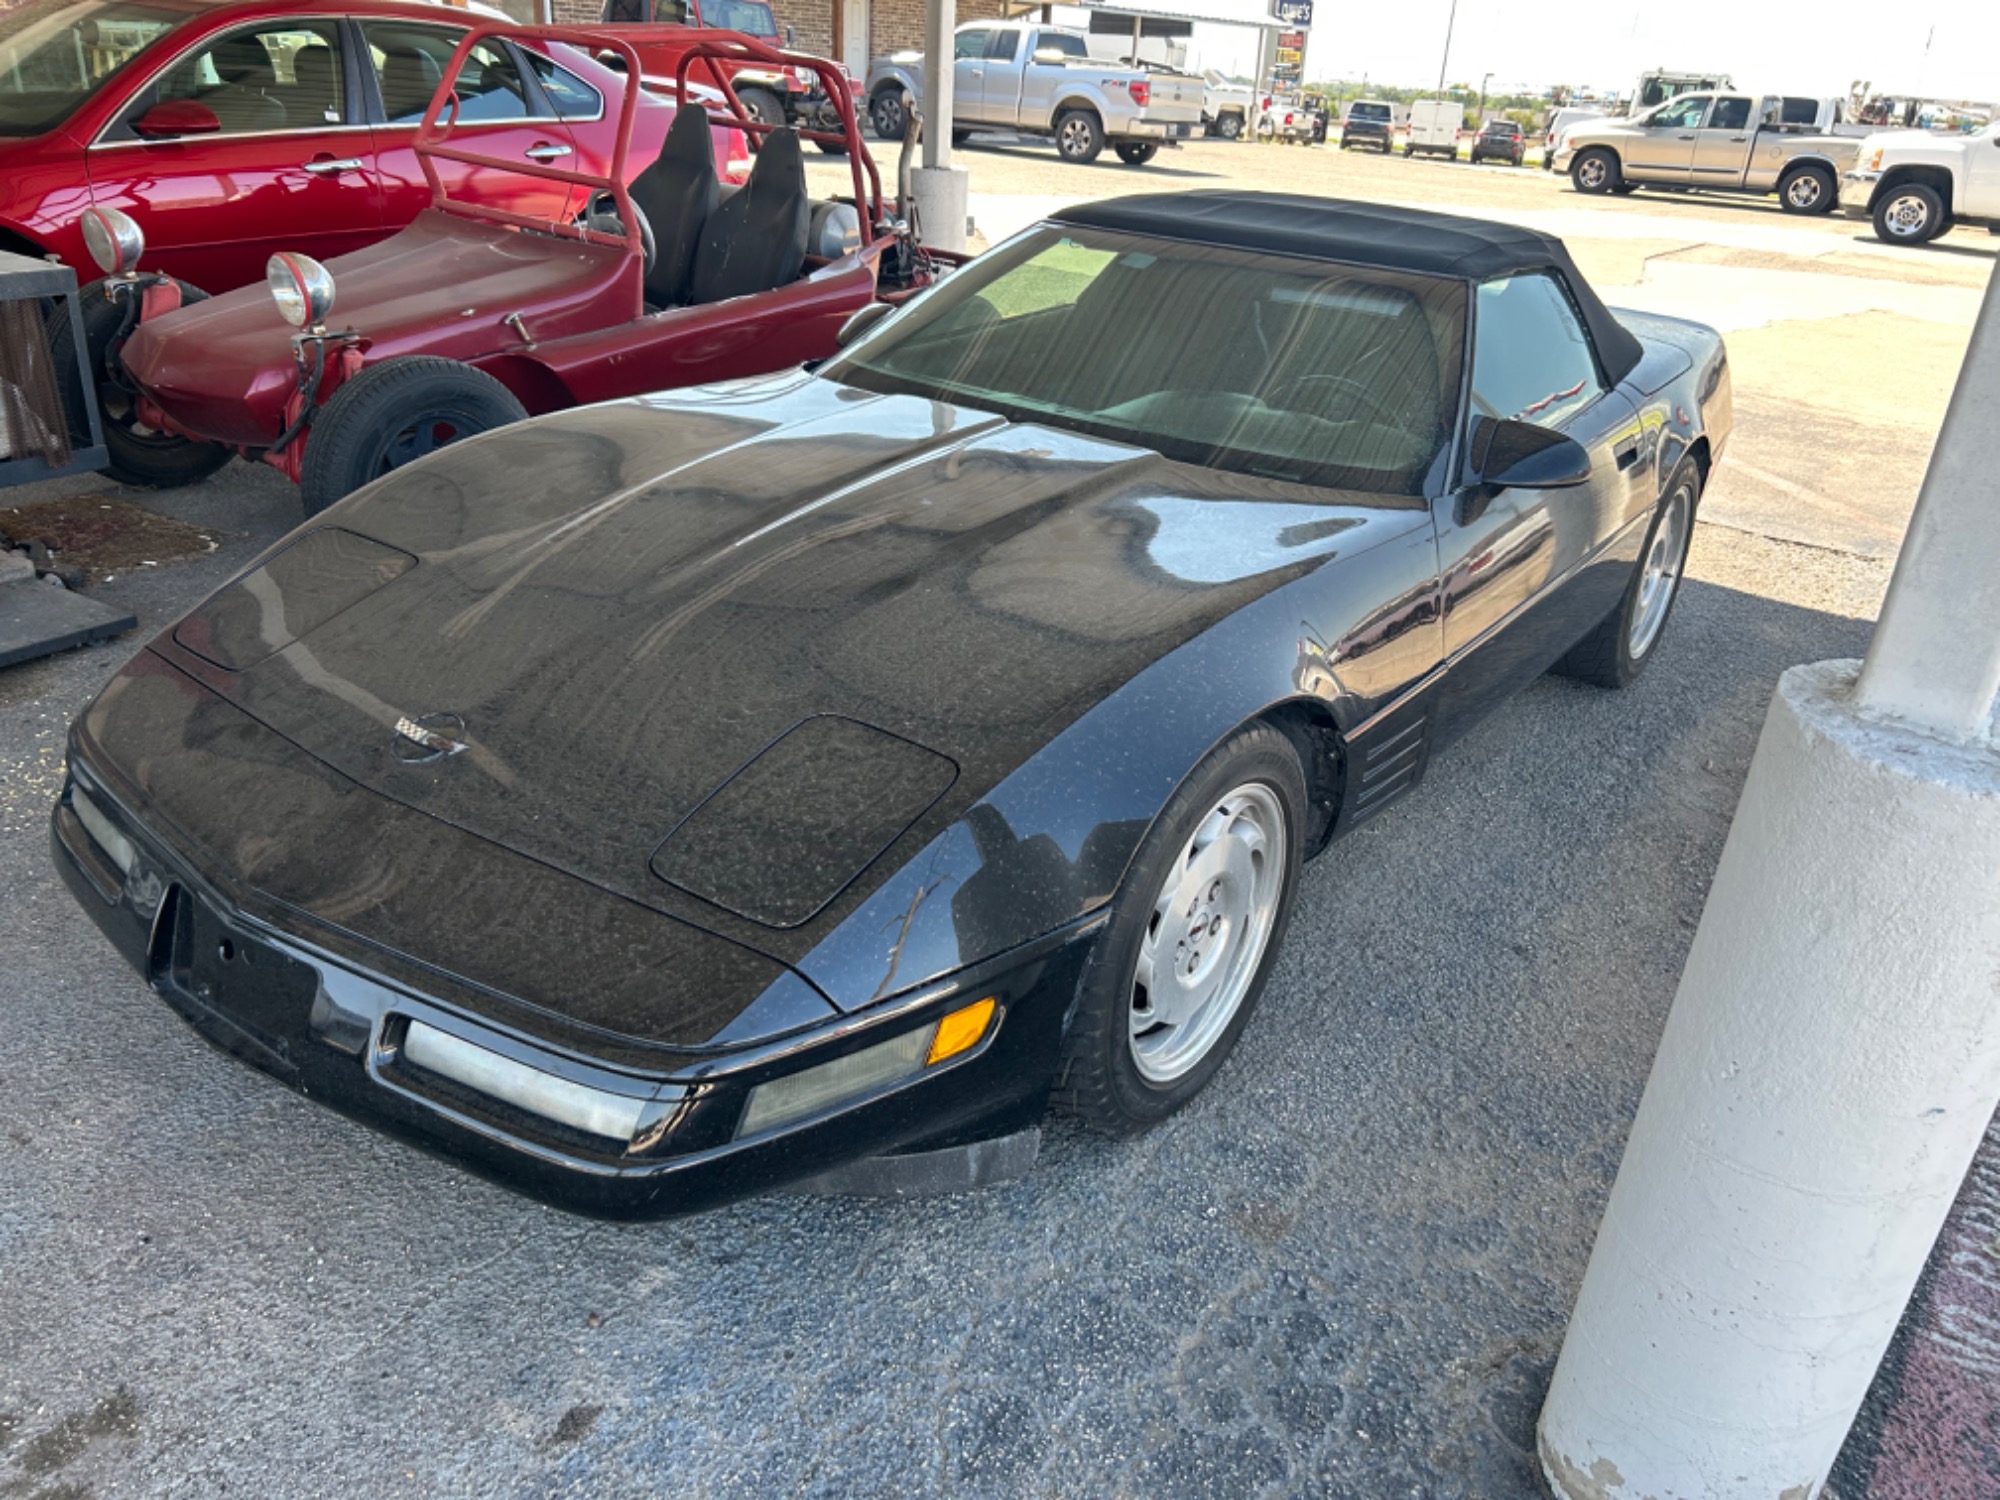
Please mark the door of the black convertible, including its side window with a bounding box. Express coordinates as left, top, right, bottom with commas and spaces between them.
1438, 272, 1644, 728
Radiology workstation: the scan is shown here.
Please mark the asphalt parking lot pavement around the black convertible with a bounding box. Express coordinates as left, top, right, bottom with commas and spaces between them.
0, 140, 2000, 1500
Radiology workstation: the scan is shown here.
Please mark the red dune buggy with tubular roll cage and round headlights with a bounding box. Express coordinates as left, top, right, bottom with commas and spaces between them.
58, 22, 938, 516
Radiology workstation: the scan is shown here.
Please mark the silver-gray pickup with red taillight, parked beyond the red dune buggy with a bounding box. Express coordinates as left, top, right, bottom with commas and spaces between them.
868, 20, 1202, 166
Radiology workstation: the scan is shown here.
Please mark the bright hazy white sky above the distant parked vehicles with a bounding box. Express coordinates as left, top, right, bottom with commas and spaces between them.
1056, 0, 2000, 100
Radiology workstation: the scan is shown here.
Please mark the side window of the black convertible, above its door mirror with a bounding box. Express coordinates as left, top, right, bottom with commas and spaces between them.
1472, 272, 1604, 428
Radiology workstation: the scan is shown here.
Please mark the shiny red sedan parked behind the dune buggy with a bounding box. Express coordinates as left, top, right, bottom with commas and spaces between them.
0, 0, 746, 292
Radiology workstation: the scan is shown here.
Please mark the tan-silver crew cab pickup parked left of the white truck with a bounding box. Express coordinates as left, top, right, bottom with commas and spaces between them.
1554, 90, 1860, 214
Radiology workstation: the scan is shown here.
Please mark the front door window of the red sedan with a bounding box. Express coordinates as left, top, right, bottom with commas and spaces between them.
138, 20, 348, 136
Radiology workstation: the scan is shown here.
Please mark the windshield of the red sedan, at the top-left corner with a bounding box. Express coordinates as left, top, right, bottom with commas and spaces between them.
0, 0, 188, 136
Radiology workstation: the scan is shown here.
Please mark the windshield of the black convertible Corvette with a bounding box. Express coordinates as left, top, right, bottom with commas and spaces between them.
822, 224, 1466, 494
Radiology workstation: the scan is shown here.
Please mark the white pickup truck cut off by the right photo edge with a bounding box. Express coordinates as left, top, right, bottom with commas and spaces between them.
1840, 120, 2000, 244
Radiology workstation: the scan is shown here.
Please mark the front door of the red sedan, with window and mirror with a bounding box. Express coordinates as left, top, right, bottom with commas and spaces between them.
84, 16, 382, 292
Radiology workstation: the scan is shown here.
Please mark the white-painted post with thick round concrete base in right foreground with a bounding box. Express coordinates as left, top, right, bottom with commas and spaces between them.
1540, 276, 2000, 1500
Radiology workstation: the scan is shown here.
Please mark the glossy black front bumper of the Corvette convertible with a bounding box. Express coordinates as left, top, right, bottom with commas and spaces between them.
50, 744, 1098, 1218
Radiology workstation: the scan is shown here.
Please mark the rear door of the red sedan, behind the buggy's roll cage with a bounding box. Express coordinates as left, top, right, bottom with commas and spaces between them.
356, 16, 584, 228
